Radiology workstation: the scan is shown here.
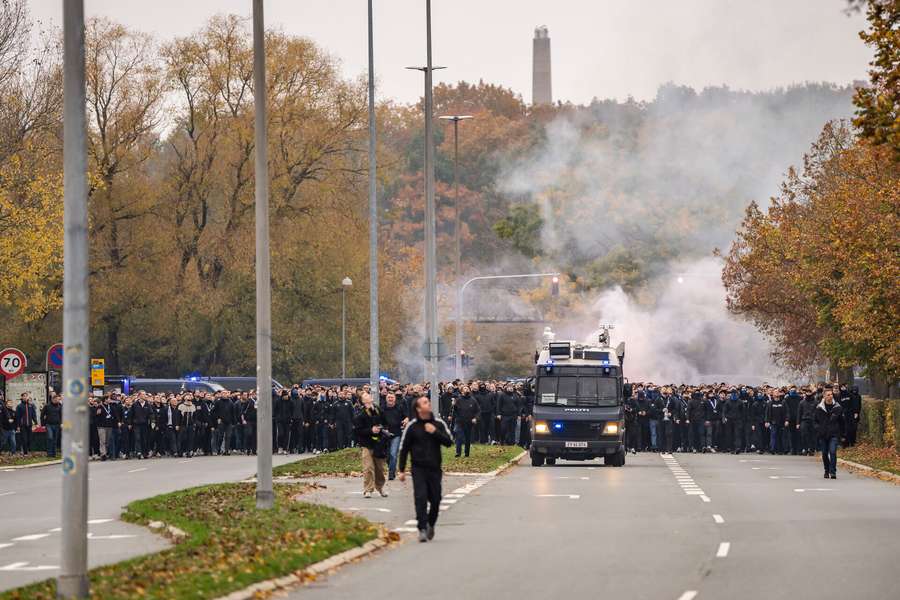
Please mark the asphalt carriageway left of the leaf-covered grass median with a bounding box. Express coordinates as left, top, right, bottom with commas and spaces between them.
0, 455, 298, 590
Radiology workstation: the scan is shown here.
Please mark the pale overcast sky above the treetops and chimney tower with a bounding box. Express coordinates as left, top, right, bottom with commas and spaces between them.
29, 0, 871, 103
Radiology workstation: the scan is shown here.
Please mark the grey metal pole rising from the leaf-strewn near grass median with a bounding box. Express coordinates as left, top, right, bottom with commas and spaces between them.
253, 0, 275, 509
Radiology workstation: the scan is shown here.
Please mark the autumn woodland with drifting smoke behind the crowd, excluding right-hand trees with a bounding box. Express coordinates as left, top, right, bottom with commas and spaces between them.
0, 3, 892, 380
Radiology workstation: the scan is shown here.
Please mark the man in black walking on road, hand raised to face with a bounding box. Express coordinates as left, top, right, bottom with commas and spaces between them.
399, 396, 453, 542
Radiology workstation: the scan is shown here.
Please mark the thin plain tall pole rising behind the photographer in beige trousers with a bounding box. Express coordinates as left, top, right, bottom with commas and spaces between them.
369, 0, 381, 400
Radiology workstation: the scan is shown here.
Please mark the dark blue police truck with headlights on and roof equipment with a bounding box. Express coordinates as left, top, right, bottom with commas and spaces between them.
531, 325, 631, 467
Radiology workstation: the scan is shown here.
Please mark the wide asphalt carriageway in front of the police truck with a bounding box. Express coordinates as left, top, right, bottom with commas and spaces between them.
289, 454, 900, 600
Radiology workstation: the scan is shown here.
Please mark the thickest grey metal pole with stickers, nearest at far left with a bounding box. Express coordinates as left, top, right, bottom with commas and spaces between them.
56, 0, 90, 598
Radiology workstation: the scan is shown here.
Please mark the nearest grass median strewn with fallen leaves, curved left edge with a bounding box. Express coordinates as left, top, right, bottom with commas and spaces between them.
0, 483, 378, 600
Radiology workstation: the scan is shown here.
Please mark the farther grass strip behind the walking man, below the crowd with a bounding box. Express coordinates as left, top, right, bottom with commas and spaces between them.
274, 444, 522, 477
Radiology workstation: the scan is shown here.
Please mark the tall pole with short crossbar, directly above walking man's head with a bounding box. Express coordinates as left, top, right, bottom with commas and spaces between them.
425, 0, 439, 402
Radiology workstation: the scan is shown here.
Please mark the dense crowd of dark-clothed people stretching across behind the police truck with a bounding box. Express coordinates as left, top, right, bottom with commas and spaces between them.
0, 381, 861, 479
